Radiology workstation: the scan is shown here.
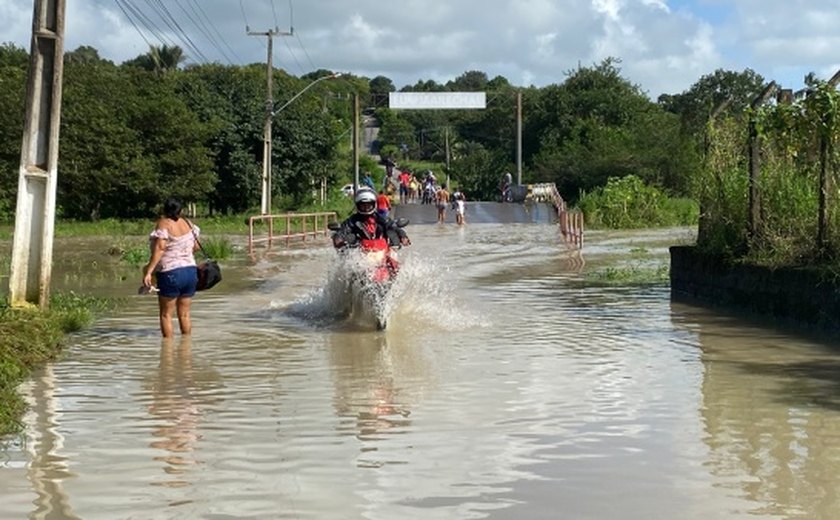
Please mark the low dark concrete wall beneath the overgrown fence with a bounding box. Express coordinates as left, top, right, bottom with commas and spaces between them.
670, 246, 840, 330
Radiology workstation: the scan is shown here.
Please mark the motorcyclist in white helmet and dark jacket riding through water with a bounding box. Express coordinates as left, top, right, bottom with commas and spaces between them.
332, 187, 411, 249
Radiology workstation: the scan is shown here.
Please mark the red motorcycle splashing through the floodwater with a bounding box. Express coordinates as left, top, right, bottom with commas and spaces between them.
327, 218, 408, 330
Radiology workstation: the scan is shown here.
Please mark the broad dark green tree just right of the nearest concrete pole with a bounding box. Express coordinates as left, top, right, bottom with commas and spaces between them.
58, 62, 215, 219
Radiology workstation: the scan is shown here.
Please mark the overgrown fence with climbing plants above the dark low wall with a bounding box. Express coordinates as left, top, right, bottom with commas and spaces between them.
692, 77, 840, 269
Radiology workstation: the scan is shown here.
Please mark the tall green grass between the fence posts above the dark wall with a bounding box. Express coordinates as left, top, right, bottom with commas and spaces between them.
695, 106, 840, 268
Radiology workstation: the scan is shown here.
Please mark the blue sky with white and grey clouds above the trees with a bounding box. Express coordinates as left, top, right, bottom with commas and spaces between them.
0, 0, 840, 100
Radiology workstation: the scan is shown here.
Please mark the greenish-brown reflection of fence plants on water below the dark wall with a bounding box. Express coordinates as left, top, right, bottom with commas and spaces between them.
675, 306, 840, 518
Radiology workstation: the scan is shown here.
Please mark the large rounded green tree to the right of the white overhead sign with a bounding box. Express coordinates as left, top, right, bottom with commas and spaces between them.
525, 59, 696, 199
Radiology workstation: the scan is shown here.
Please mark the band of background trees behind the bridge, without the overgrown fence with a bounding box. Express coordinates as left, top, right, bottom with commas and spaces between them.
0, 45, 720, 220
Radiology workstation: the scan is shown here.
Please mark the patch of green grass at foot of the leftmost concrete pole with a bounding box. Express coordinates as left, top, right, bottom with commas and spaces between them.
0, 292, 114, 436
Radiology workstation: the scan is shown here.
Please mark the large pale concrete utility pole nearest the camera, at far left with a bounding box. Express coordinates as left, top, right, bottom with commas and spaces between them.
9, 0, 65, 309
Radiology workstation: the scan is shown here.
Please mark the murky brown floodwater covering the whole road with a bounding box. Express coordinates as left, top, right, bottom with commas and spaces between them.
0, 204, 840, 520
